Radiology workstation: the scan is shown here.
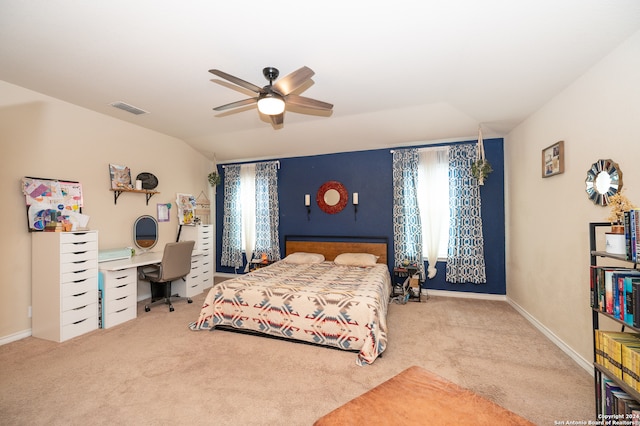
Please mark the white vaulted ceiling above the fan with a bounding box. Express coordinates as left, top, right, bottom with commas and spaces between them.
0, 0, 640, 162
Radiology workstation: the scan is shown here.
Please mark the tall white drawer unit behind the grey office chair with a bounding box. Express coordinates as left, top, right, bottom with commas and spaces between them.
171, 225, 215, 297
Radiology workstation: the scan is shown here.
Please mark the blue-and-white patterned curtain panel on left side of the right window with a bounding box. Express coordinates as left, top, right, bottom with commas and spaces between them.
393, 149, 424, 279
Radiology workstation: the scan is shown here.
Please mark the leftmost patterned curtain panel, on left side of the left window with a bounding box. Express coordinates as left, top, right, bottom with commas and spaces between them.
220, 165, 243, 269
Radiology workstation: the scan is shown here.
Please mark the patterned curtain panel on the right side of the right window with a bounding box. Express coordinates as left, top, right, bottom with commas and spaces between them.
446, 144, 487, 284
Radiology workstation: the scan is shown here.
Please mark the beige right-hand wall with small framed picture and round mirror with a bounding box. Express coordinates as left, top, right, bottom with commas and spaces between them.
505, 32, 640, 363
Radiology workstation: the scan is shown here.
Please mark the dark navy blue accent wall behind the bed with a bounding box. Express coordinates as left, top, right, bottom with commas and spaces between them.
216, 139, 506, 295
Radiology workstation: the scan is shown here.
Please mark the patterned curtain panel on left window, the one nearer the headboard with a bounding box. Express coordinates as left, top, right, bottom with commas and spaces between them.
252, 161, 280, 260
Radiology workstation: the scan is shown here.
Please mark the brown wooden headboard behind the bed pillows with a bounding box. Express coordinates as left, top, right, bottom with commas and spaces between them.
285, 235, 388, 265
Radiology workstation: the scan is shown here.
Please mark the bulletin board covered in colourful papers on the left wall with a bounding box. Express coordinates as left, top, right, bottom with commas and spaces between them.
21, 176, 89, 232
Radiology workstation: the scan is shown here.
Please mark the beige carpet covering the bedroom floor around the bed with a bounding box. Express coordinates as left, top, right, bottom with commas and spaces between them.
0, 288, 595, 425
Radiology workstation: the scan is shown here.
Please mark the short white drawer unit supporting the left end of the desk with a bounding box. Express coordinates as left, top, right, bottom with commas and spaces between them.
99, 267, 138, 328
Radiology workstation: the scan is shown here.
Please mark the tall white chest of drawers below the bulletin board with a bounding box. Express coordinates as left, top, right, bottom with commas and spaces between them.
31, 231, 98, 342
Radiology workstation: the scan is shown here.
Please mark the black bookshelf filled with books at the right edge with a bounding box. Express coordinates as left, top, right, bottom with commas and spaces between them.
589, 222, 640, 419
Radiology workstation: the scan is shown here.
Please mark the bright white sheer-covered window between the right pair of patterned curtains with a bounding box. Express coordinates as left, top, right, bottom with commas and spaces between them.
417, 146, 449, 263
